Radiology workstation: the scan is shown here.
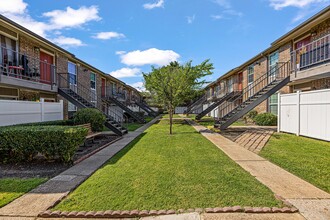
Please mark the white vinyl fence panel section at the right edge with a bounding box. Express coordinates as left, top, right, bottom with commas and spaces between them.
278, 89, 330, 141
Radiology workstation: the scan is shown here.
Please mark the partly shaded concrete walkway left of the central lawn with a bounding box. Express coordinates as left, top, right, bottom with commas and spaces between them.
0, 117, 160, 219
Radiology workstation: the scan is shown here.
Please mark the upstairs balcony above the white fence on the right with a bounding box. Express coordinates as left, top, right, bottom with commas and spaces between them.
290, 34, 330, 81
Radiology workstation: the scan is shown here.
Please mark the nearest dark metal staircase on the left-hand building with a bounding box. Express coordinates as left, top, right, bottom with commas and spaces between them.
58, 74, 127, 136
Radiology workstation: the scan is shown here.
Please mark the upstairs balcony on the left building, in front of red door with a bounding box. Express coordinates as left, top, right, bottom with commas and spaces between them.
0, 47, 57, 92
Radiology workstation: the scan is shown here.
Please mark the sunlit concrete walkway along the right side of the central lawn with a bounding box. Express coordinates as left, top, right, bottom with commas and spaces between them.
187, 120, 330, 220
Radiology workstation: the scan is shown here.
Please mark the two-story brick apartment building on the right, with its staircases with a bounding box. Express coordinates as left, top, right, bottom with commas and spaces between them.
191, 6, 330, 129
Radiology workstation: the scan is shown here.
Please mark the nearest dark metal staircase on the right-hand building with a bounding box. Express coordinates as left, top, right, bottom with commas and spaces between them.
214, 62, 290, 130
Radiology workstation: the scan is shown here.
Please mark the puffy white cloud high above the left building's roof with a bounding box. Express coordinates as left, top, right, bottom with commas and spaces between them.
43, 5, 101, 29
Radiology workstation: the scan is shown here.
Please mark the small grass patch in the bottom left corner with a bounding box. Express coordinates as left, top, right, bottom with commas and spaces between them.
0, 178, 46, 207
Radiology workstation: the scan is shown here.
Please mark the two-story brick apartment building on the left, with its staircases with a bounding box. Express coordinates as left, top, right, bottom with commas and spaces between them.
0, 15, 148, 133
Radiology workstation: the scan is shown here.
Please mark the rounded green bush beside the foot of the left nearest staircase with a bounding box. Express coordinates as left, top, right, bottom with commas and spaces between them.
73, 108, 106, 132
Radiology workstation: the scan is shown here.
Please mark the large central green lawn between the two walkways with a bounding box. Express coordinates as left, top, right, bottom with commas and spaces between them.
54, 120, 282, 211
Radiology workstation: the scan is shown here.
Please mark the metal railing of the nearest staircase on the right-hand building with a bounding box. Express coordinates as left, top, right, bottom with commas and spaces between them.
214, 61, 290, 121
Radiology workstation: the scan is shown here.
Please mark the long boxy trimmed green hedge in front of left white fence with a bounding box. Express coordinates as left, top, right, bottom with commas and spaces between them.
0, 126, 88, 163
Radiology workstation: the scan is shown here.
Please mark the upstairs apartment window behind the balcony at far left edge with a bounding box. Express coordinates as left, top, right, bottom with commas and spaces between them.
0, 34, 18, 66
